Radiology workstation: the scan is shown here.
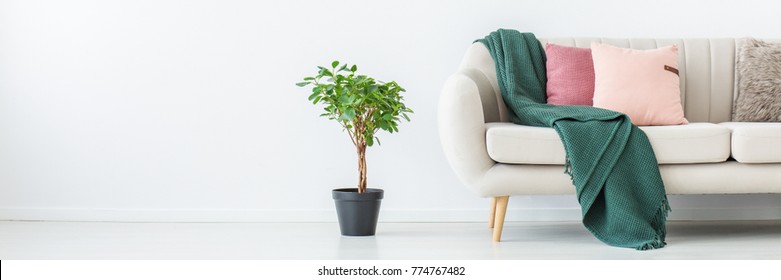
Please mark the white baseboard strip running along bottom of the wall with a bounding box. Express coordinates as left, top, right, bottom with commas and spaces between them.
0, 207, 781, 223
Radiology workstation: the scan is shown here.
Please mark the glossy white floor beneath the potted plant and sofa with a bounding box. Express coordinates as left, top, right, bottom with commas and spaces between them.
0, 221, 781, 260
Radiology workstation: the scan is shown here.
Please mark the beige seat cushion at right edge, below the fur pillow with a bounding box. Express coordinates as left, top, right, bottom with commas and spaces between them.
720, 122, 781, 163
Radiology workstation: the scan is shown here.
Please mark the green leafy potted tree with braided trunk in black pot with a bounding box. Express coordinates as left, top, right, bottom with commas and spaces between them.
296, 61, 412, 236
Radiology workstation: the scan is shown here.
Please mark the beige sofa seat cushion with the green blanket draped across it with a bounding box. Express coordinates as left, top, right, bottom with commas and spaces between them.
486, 123, 730, 165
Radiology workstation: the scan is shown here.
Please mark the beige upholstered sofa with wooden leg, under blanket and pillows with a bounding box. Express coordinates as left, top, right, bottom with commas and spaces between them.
438, 38, 781, 241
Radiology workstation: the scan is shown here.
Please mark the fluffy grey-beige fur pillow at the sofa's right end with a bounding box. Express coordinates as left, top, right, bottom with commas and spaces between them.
732, 38, 781, 122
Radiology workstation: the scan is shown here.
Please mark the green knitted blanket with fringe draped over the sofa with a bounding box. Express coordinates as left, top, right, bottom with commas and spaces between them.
478, 29, 670, 250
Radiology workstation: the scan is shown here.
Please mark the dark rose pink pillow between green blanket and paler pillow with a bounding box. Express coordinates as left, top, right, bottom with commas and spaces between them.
545, 43, 594, 106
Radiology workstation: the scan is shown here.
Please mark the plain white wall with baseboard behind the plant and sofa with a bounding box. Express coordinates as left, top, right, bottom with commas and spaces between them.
0, 0, 781, 221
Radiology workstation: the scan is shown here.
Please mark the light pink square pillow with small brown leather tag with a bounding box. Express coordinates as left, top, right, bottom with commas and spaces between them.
591, 43, 689, 125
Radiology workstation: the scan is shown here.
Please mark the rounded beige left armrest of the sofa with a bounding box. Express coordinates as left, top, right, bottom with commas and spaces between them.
438, 69, 496, 193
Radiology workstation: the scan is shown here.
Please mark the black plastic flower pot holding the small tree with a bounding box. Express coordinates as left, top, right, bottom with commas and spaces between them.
331, 188, 384, 236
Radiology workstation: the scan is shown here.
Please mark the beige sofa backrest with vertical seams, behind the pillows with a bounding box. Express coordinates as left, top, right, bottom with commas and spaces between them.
460, 38, 772, 123
